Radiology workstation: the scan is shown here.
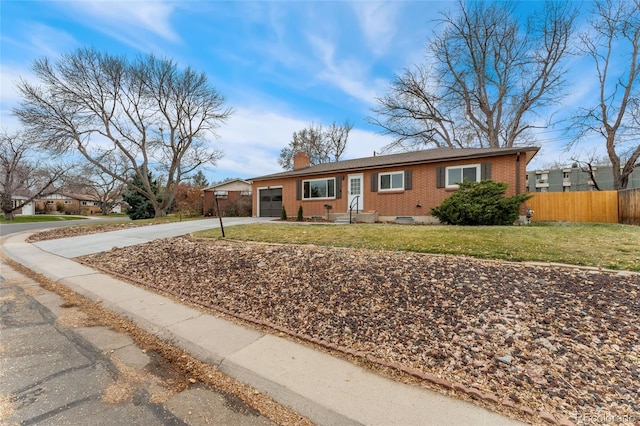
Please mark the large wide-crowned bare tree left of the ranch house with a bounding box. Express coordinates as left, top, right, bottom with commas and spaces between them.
14, 49, 231, 217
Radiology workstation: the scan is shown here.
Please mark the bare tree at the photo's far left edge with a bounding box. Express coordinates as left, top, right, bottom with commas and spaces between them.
0, 130, 70, 220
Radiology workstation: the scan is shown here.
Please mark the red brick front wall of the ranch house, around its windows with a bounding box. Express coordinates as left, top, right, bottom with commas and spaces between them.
253, 153, 527, 216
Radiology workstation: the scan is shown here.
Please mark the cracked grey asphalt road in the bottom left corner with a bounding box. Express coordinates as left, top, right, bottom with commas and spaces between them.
0, 259, 272, 426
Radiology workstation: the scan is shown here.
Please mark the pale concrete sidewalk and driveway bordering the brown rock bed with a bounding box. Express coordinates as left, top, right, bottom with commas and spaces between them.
2, 219, 521, 425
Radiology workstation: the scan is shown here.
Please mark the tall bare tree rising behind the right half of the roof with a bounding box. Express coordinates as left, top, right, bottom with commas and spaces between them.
369, 1, 576, 150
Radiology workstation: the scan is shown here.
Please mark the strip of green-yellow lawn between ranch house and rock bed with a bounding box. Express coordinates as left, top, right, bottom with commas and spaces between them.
195, 223, 640, 271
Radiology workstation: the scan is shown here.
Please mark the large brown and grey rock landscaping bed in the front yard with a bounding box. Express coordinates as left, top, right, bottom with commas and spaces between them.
78, 237, 640, 424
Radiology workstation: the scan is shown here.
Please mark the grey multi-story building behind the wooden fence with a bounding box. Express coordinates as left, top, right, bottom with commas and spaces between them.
527, 166, 640, 192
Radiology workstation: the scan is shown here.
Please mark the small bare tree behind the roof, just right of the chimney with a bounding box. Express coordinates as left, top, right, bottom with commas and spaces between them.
278, 121, 353, 170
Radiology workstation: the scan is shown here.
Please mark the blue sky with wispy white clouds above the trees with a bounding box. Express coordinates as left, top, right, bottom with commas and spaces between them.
0, 0, 604, 181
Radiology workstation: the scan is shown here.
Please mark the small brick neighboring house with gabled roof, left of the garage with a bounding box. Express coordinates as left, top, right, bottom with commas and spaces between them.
202, 179, 251, 216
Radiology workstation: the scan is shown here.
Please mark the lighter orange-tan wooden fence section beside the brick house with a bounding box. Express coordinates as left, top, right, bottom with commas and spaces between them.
526, 191, 620, 223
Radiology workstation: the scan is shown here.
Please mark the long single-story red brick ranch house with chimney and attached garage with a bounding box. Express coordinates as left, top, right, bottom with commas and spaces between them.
253, 147, 539, 223
